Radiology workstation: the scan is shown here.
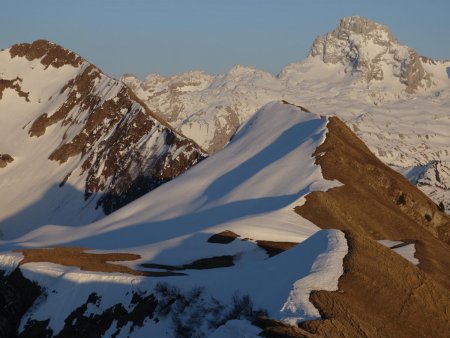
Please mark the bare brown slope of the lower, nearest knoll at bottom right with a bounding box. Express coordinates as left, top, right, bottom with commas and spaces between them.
300, 234, 450, 338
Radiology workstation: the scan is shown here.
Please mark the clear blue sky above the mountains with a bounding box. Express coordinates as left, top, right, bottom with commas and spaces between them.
0, 0, 450, 77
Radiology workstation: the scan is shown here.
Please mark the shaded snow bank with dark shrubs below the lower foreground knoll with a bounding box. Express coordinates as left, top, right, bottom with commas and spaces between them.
10, 230, 347, 337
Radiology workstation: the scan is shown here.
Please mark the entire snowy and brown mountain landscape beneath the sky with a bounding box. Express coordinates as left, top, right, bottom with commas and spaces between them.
0, 16, 450, 338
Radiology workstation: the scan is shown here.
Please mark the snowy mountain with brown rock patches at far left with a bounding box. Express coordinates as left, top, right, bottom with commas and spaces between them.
0, 40, 203, 238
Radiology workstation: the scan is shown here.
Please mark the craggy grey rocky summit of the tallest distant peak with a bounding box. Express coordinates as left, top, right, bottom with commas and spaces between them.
310, 16, 431, 93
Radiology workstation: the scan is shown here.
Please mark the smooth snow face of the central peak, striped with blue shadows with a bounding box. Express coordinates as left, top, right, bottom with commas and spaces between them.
8, 102, 339, 252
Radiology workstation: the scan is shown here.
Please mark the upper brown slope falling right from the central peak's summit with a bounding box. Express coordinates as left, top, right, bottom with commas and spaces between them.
297, 117, 450, 243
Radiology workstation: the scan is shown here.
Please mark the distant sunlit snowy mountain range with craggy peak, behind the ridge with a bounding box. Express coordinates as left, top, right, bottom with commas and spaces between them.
122, 17, 450, 210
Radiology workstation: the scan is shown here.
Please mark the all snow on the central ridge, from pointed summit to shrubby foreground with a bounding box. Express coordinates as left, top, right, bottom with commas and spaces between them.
1, 102, 347, 337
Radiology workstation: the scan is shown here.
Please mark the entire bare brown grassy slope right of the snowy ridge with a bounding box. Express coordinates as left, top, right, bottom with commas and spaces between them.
284, 118, 450, 337
